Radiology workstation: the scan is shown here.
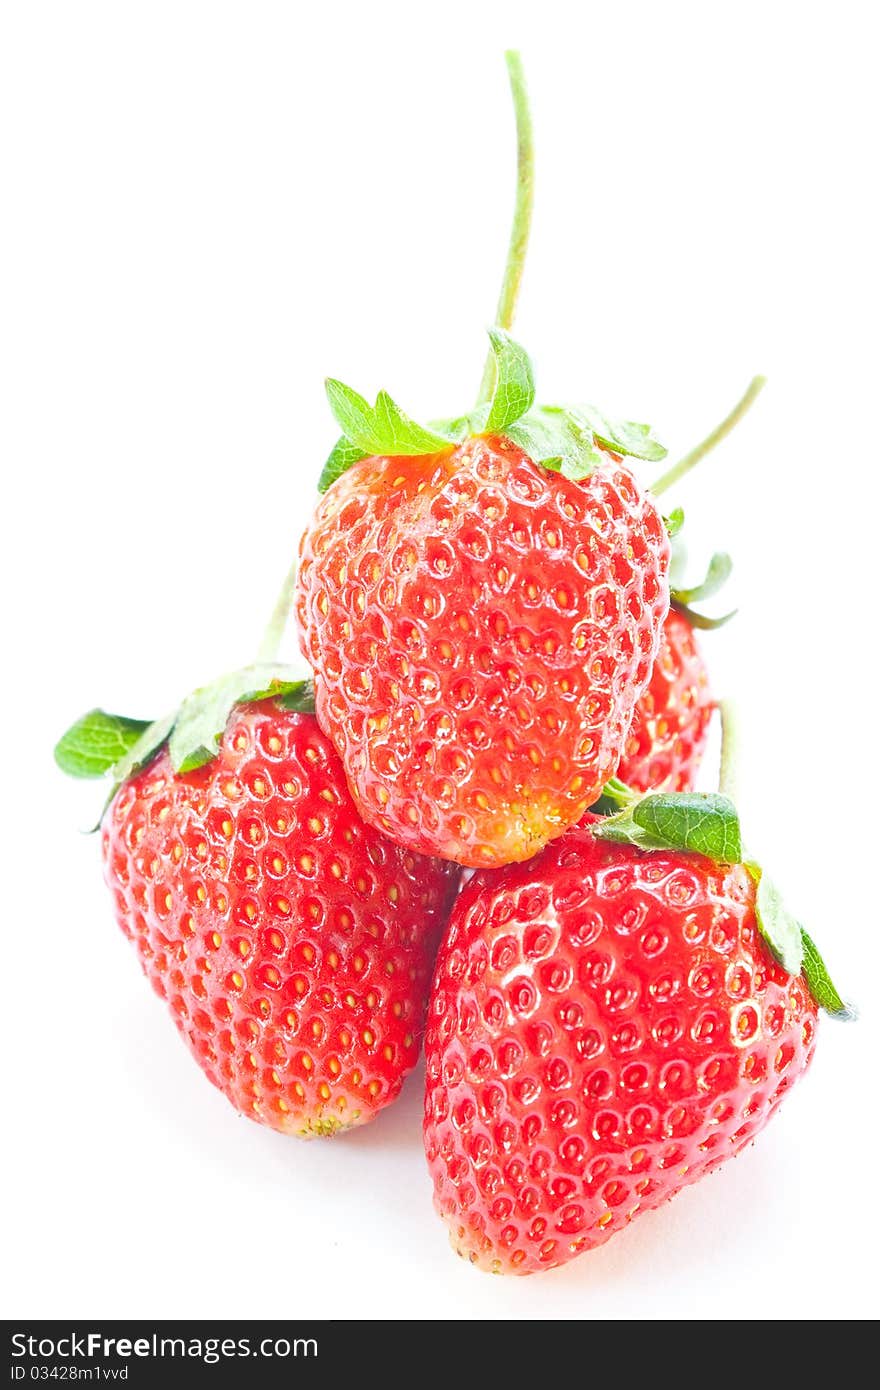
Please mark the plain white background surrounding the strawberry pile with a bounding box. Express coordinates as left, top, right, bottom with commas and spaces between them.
0, 0, 880, 1319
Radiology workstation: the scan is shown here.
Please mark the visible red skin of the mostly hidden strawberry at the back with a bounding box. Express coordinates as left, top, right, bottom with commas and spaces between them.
617, 609, 715, 791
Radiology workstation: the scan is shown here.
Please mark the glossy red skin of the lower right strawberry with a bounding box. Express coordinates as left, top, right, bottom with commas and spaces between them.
424, 824, 816, 1275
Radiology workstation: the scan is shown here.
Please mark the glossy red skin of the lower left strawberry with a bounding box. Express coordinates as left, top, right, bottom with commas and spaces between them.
101, 701, 453, 1137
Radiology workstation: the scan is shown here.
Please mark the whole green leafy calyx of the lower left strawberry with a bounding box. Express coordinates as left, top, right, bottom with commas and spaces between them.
54, 662, 314, 795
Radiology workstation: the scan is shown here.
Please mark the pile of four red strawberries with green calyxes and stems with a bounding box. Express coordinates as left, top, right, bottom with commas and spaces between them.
56, 58, 848, 1273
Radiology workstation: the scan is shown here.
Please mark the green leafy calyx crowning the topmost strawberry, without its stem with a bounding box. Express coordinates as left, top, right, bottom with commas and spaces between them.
318, 327, 666, 492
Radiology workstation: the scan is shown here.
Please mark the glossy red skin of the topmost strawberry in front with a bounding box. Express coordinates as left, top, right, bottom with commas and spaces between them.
296, 436, 669, 866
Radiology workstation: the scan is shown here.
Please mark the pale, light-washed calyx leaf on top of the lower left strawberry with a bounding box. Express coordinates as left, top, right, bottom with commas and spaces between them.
168, 664, 312, 773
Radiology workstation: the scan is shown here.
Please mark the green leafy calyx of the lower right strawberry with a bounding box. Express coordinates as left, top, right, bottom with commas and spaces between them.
592, 777, 855, 1020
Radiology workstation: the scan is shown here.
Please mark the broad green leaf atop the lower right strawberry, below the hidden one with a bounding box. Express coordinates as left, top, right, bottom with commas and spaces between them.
594, 792, 742, 863
